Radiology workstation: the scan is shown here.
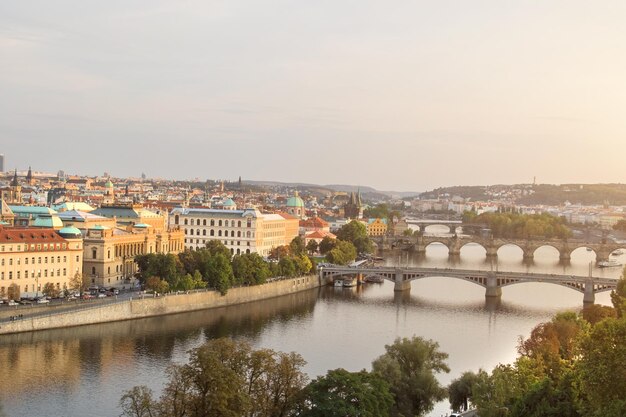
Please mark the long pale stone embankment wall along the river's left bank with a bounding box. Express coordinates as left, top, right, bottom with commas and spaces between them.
0, 275, 322, 335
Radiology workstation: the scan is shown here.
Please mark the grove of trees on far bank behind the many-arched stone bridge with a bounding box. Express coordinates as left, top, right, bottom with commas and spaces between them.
463, 212, 572, 239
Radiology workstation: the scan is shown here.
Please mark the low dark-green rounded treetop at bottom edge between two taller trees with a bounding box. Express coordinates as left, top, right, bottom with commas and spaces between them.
297, 369, 393, 417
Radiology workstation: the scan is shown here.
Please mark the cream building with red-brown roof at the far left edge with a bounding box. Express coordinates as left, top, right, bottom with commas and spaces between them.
0, 225, 83, 299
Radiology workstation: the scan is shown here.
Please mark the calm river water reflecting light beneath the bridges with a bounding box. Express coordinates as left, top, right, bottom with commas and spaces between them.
0, 228, 621, 417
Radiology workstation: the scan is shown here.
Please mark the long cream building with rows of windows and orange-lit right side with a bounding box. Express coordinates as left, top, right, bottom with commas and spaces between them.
169, 207, 299, 256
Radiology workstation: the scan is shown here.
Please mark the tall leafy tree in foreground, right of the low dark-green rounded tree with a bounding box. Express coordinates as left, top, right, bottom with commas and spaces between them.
372, 336, 450, 417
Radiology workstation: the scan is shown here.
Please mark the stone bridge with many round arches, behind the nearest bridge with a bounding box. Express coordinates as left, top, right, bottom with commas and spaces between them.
373, 234, 626, 262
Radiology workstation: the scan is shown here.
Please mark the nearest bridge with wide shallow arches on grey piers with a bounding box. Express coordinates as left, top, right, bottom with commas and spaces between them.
319, 266, 617, 304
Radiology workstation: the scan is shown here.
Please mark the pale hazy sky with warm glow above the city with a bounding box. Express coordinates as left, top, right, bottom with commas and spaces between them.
0, 0, 626, 191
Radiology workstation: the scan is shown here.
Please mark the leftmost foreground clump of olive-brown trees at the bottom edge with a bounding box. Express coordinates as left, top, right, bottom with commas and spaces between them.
121, 338, 306, 417
